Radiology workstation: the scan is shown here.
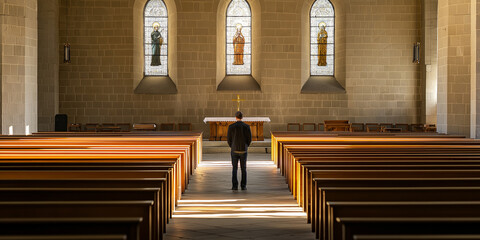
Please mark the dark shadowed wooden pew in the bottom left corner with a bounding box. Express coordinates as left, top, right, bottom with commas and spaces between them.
0, 217, 143, 240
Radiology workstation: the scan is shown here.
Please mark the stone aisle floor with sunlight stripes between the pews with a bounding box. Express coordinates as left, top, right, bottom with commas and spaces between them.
165, 153, 314, 240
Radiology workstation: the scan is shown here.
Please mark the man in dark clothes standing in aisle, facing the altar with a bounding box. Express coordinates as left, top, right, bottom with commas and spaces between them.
227, 111, 252, 190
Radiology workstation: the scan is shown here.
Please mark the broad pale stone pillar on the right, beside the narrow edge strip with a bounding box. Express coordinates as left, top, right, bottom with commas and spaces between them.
437, 0, 471, 137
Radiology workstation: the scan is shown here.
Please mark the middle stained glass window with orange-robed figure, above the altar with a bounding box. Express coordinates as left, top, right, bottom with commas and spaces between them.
226, 0, 252, 75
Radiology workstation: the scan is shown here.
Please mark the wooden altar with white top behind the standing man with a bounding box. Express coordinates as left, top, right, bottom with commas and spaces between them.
203, 117, 270, 141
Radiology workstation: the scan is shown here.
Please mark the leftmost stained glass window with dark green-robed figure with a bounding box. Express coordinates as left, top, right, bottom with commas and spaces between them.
143, 0, 168, 76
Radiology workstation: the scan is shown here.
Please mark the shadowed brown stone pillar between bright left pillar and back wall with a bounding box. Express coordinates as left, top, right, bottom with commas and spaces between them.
38, 0, 60, 131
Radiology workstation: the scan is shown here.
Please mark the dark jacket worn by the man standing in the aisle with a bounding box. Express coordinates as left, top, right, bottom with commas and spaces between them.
227, 121, 252, 152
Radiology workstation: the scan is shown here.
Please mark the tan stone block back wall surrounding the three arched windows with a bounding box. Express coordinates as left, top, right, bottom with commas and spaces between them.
59, 0, 422, 136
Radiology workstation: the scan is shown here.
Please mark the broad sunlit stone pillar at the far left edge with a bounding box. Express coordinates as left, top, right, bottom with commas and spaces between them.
1, 0, 38, 134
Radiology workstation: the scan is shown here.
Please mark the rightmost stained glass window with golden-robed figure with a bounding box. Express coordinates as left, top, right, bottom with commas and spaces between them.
310, 0, 335, 76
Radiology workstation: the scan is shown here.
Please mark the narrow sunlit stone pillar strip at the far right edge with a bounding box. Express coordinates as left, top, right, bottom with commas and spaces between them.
470, 0, 480, 138
